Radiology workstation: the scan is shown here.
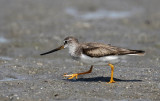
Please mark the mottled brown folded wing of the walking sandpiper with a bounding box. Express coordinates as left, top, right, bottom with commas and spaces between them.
82, 43, 132, 57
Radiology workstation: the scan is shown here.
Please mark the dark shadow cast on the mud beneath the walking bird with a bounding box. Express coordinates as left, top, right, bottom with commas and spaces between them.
63, 76, 142, 82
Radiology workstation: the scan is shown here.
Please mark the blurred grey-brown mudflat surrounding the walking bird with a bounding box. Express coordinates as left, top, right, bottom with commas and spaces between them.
0, 0, 160, 101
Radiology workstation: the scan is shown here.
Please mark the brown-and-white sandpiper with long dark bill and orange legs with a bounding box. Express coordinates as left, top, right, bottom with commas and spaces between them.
40, 36, 145, 83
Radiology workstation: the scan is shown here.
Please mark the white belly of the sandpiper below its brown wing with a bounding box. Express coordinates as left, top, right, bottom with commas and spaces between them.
80, 54, 119, 65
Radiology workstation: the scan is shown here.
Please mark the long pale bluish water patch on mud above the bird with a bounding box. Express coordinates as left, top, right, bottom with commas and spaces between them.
65, 8, 141, 20
